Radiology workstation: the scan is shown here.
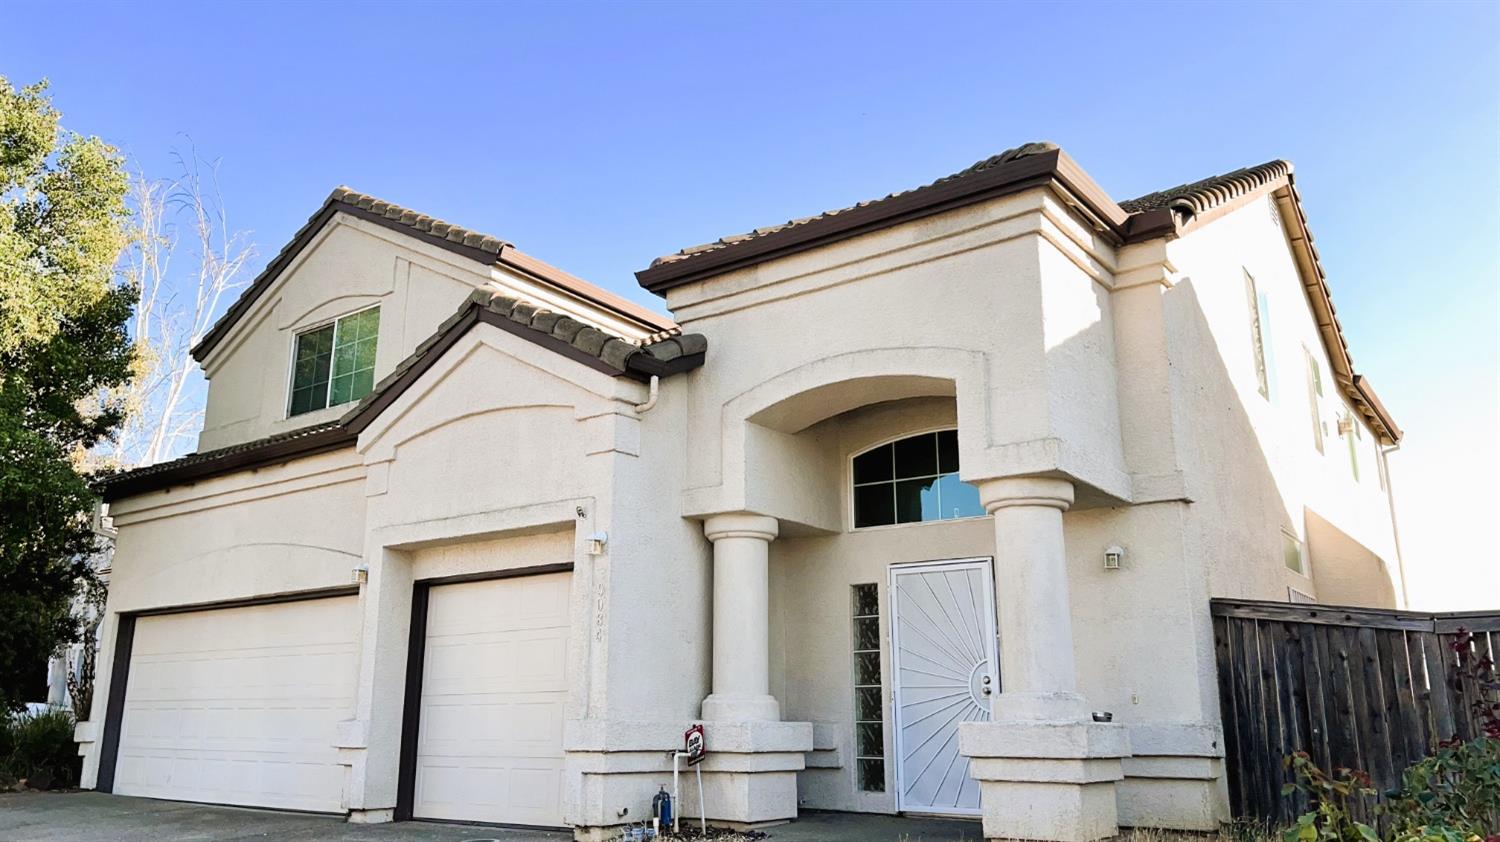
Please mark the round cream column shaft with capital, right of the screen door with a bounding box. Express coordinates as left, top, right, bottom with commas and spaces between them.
980, 477, 1088, 720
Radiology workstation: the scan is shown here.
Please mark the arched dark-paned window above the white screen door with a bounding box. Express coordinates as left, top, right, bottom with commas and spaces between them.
854, 429, 984, 528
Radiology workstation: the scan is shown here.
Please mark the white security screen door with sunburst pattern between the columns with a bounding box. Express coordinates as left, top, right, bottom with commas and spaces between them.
890, 558, 1001, 815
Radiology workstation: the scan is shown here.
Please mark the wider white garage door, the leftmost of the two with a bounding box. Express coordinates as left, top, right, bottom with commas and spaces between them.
114, 596, 360, 812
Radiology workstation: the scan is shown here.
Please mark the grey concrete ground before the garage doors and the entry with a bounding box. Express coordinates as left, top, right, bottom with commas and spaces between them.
0, 792, 981, 842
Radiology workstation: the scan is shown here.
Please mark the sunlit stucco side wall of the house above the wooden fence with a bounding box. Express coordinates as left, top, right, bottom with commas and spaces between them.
1164, 198, 1401, 606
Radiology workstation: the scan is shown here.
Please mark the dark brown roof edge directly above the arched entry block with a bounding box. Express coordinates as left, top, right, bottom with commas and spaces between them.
636, 143, 1130, 296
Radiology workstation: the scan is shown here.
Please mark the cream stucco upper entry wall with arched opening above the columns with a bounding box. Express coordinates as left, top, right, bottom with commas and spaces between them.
668, 191, 1130, 530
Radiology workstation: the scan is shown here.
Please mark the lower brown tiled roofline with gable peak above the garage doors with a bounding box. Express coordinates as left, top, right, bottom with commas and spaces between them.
105, 290, 708, 503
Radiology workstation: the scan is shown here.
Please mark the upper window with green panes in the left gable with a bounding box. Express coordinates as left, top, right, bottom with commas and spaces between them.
287, 308, 380, 416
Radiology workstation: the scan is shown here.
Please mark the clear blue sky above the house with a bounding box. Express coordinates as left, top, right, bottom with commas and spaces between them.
0, 2, 1500, 603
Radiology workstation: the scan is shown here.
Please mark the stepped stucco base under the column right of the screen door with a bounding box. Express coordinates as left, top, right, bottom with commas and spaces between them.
959, 720, 1130, 842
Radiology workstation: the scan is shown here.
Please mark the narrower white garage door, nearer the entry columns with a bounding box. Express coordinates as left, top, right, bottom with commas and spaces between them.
413, 573, 573, 825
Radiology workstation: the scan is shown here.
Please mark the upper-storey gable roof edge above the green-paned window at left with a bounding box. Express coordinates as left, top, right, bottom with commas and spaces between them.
192, 186, 677, 362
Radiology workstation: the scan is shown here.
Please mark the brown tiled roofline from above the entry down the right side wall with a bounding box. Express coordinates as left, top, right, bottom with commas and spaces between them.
636, 141, 1401, 444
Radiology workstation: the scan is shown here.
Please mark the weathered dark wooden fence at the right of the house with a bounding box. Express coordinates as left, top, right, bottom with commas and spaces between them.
1212, 599, 1500, 824
